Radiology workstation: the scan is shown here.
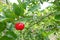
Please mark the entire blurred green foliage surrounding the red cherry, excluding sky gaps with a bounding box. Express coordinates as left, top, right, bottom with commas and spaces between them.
0, 0, 60, 40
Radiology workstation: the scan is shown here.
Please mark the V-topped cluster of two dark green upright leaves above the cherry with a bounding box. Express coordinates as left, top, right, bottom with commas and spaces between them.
13, 3, 26, 16
